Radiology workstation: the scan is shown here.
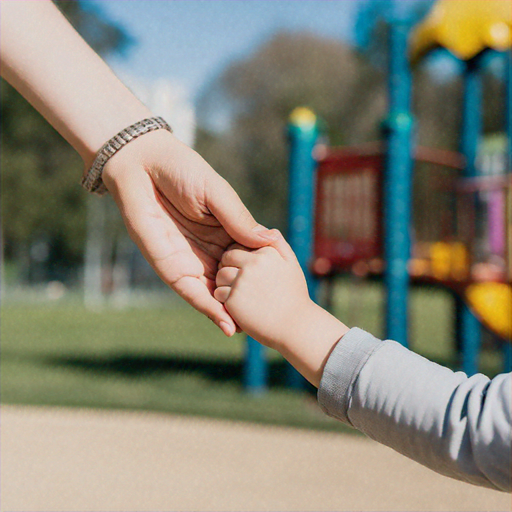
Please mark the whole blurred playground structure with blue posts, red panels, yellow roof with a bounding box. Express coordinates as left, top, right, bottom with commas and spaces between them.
245, 0, 512, 392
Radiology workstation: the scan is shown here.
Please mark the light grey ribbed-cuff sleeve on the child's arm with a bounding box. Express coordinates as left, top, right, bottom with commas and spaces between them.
318, 329, 512, 492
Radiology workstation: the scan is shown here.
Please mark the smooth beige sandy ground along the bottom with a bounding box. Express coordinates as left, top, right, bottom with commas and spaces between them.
0, 406, 511, 512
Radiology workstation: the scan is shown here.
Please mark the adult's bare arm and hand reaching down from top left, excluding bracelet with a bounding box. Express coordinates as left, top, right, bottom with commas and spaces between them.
0, 0, 271, 335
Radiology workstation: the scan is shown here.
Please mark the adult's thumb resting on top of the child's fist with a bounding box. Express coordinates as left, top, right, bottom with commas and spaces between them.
208, 178, 279, 249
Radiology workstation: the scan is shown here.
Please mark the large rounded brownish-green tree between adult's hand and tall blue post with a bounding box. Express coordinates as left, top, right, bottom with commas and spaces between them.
197, 32, 385, 229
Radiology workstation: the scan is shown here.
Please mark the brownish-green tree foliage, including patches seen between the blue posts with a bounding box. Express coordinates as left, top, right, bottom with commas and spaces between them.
197, 30, 503, 234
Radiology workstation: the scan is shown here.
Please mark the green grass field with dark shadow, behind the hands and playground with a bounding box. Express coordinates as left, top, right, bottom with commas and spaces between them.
1, 280, 500, 430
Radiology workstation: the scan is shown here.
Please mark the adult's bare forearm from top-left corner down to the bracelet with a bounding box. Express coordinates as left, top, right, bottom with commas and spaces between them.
0, 0, 151, 166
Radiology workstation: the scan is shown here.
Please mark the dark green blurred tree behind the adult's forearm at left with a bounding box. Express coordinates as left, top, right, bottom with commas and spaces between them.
0, 1, 130, 280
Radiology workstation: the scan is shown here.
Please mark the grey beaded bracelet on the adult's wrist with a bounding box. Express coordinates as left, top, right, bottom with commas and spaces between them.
81, 117, 172, 196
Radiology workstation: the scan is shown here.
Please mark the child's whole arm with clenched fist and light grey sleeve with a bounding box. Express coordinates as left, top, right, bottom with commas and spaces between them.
215, 235, 512, 491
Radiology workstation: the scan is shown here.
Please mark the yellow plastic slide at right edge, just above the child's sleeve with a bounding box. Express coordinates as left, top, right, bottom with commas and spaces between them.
465, 283, 512, 341
